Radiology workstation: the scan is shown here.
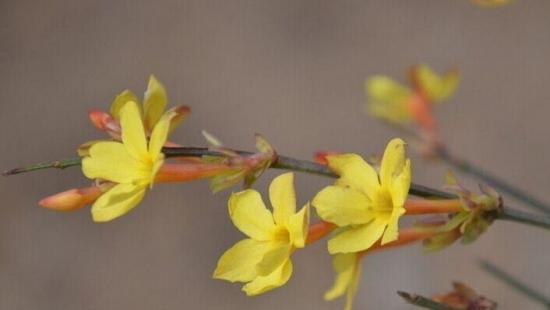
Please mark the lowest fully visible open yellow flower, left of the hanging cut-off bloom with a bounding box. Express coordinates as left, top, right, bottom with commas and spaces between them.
214, 173, 309, 296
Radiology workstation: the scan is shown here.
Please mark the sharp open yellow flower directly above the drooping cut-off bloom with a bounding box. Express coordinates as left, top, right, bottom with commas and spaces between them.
312, 139, 411, 254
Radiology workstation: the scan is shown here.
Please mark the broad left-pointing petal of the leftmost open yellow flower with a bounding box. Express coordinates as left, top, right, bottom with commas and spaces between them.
82, 141, 144, 183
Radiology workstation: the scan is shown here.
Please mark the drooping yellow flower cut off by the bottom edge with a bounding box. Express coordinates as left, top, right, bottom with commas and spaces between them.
324, 253, 361, 310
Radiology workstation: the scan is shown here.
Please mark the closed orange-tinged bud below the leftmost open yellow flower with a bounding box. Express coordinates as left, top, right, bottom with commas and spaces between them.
38, 186, 107, 211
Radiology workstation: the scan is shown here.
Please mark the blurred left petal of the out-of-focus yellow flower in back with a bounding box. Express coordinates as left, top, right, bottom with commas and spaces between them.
365, 76, 412, 123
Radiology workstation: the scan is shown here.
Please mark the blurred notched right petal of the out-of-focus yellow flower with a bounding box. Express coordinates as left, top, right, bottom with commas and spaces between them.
415, 64, 460, 102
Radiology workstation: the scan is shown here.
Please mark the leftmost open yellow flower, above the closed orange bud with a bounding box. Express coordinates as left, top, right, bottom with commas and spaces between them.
82, 101, 173, 222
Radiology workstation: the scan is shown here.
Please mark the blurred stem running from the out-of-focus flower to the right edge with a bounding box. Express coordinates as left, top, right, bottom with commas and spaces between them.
442, 147, 550, 214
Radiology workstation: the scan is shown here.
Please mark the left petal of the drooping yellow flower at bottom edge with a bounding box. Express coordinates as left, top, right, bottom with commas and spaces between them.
324, 253, 357, 300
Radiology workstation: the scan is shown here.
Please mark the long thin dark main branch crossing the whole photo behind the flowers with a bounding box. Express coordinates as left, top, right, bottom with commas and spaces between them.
3, 147, 550, 229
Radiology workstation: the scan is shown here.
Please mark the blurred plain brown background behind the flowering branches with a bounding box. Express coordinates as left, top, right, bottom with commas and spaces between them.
0, 0, 550, 310
